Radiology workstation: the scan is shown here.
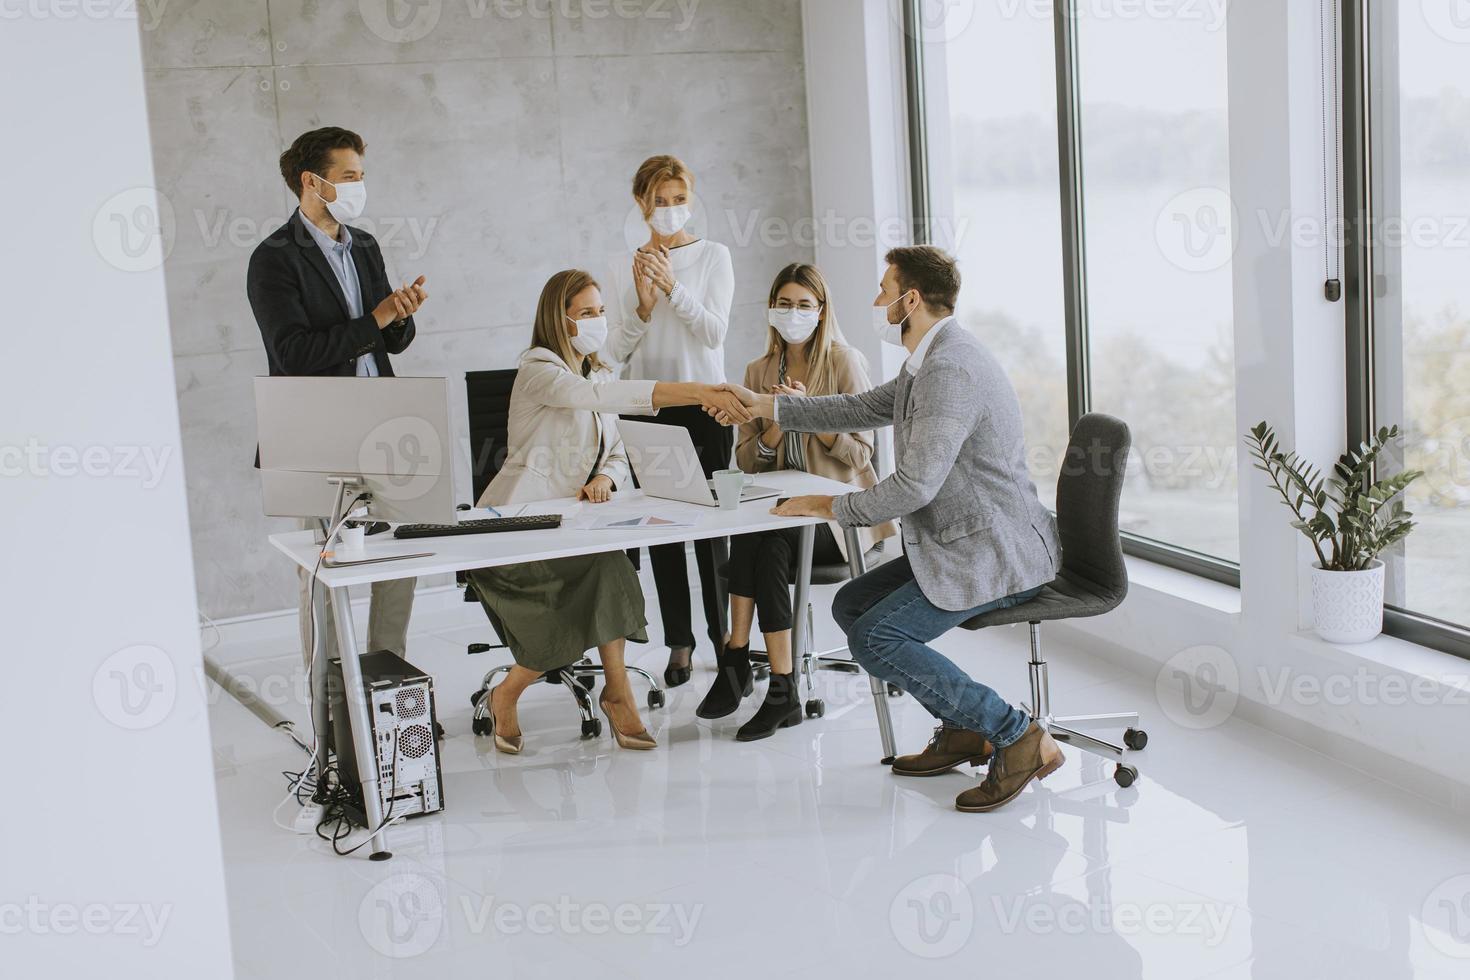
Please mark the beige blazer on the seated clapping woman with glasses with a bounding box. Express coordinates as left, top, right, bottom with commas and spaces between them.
735, 347, 898, 558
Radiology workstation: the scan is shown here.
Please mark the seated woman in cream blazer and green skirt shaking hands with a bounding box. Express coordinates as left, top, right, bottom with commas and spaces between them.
469, 269, 750, 754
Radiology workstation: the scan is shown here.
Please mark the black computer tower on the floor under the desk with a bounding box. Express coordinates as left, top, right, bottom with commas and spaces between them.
328, 651, 444, 826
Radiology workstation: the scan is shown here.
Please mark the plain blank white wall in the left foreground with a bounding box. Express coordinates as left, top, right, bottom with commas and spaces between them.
0, 3, 232, 980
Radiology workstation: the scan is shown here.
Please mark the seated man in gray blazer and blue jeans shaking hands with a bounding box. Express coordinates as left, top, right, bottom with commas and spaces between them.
708, 247, 1063, 813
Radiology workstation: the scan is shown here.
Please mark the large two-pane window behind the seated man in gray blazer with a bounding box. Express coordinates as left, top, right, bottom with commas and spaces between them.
907, 0, 1239, 582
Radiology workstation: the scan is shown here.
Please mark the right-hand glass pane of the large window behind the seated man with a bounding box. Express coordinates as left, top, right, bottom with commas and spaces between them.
1076, 3, 1241, 561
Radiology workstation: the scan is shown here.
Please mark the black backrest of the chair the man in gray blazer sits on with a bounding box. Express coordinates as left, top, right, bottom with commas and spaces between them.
1057, 414, 1133, 602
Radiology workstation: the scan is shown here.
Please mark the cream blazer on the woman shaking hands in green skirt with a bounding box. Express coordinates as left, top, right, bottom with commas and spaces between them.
479, 347, 657, 507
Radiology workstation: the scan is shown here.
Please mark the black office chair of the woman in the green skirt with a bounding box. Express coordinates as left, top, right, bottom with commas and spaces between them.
459, 370, 664, 739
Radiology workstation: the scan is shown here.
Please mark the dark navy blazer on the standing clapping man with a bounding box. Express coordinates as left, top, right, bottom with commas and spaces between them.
245, 212, 415, 378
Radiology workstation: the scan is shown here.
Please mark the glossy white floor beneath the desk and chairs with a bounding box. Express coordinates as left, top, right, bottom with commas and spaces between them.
212, 567, 1470, 980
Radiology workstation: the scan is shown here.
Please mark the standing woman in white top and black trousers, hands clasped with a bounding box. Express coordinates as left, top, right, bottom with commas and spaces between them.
607, 156, 735, 688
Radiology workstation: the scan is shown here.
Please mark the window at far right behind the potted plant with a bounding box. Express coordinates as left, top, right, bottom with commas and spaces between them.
1344, 3, 1470, 652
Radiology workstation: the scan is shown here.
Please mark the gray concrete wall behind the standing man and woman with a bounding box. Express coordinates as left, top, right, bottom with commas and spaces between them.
140, 0, 817, 619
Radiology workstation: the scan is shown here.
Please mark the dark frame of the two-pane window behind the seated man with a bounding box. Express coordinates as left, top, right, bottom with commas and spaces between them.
898, 0, 1241, 589
